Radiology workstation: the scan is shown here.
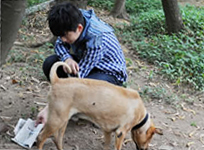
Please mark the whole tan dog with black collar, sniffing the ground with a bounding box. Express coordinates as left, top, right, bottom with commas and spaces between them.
37, 62, 162, 150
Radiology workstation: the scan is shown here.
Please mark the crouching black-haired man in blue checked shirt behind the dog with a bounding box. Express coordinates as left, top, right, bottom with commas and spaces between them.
36, 3, 127, 124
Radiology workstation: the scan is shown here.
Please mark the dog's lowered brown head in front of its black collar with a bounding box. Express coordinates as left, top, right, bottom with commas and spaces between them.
131, 115, 163, 150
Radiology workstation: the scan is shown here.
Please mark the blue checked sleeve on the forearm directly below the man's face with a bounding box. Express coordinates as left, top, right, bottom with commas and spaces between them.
55, 38, 72, 61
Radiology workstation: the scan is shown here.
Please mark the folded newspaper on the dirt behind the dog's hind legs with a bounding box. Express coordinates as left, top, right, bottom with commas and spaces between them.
12, 118, 43, 148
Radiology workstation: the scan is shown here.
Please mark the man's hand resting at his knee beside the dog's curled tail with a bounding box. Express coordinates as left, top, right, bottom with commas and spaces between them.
63, 58, 79, 75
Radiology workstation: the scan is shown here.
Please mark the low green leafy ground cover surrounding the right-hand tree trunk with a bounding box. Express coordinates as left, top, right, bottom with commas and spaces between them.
116, 6, 204, 89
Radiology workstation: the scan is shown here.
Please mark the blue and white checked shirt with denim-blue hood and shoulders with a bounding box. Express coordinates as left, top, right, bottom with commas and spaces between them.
55, 10, 127, 82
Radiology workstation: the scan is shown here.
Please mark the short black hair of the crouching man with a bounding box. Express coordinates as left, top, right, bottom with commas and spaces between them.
47, 2, 84, 36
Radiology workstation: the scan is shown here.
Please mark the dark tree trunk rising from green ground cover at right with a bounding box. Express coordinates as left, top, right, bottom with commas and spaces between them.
162, 0, 183, 34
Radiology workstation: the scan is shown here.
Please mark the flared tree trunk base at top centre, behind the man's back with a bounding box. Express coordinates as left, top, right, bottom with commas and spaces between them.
110, 0, 129, 20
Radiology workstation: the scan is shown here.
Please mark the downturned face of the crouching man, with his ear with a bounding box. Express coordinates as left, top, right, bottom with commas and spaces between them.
61, 24, 83, 44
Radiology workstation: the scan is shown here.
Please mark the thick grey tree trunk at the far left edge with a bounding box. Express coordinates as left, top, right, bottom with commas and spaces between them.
0, 0, 26, 66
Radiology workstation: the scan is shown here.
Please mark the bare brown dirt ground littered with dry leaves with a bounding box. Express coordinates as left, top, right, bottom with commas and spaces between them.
0, 1, 204, 150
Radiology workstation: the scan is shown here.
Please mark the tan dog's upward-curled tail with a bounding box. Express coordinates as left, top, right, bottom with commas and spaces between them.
50, 61, 72, 84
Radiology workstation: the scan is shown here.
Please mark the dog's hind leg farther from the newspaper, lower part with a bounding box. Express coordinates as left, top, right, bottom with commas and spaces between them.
53, 121, 68, 150
